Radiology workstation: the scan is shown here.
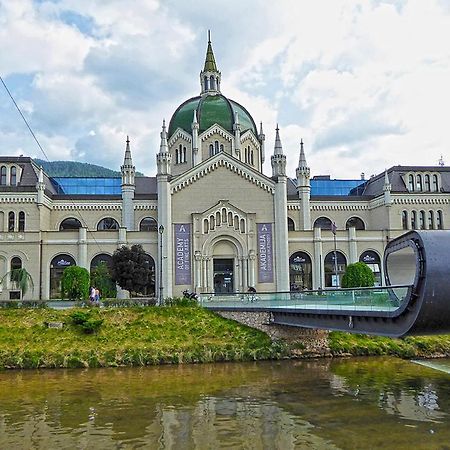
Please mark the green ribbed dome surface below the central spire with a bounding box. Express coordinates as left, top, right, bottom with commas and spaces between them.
169, 94, 258, 138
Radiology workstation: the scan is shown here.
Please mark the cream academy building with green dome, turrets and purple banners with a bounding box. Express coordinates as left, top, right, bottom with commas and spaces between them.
0, 38, 450, 299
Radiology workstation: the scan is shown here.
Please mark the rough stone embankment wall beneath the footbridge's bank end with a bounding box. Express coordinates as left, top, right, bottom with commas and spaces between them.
216, 311, 331, 357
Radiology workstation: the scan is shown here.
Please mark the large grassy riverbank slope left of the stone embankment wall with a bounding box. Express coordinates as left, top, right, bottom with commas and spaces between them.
0, 307, 288, 370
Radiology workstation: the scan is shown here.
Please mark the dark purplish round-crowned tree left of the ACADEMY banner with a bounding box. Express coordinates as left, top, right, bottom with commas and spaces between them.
111, 244, 152, 296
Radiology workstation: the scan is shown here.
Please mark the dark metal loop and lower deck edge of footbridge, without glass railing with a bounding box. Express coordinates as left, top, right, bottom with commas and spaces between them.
272, 230, 450, 337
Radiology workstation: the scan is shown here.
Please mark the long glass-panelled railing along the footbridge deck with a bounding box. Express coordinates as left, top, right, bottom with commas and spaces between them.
199, 285, 412, 311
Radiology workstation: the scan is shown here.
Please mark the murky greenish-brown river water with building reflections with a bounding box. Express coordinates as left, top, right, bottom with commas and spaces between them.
0, 358, 450, 450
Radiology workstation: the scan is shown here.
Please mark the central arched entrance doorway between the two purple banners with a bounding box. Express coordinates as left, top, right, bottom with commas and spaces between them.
213, 240, 237, 294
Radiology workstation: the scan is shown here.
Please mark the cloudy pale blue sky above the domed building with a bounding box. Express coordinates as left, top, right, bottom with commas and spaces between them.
0, 0, 450, 179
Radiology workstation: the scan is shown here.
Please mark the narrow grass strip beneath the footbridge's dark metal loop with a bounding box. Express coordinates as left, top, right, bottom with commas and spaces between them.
328, 331, 450, 358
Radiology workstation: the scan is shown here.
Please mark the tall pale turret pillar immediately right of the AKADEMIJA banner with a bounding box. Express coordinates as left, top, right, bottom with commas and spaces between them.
271, 125, 289, 292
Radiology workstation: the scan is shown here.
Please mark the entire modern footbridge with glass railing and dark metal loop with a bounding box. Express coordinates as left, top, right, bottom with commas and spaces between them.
200, 230, 450, 337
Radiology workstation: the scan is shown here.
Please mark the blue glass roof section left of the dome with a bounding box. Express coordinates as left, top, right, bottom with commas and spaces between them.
50, 177, 122, 195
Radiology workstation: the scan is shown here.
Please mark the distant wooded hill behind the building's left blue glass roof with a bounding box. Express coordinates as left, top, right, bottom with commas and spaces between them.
34, 159, 144, 178
